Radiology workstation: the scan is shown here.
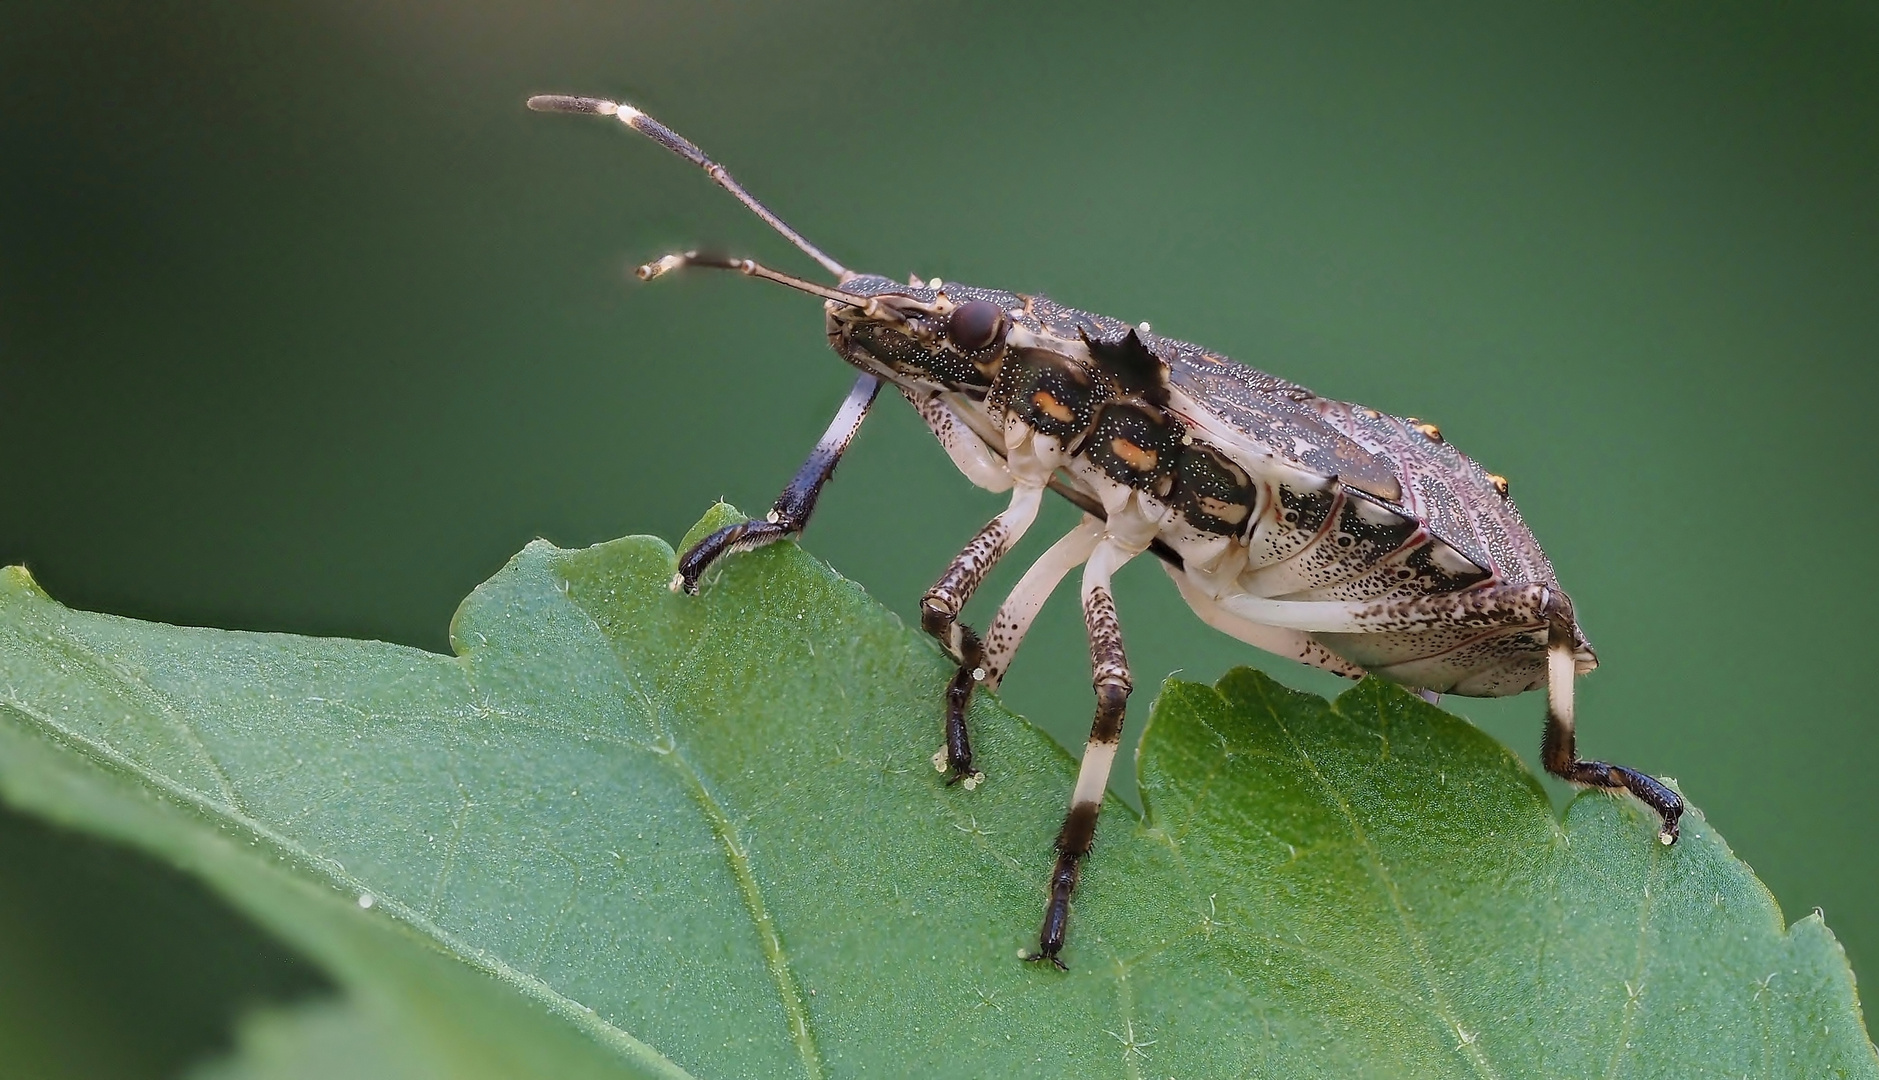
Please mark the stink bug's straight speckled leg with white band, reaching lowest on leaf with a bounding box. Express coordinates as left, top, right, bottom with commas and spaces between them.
1028, 541, 1137, 971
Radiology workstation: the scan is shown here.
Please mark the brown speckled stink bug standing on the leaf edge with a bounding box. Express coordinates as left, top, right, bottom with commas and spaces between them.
528, 96, 1684, 967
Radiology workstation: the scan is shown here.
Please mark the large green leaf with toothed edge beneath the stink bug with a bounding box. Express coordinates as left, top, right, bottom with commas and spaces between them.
0, 507, 1879, 1078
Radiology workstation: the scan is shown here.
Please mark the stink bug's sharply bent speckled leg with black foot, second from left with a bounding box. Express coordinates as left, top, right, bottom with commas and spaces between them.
921, 485, 1045, 787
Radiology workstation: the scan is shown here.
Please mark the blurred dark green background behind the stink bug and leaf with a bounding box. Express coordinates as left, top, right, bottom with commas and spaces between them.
0, 0, 1879, 1074
